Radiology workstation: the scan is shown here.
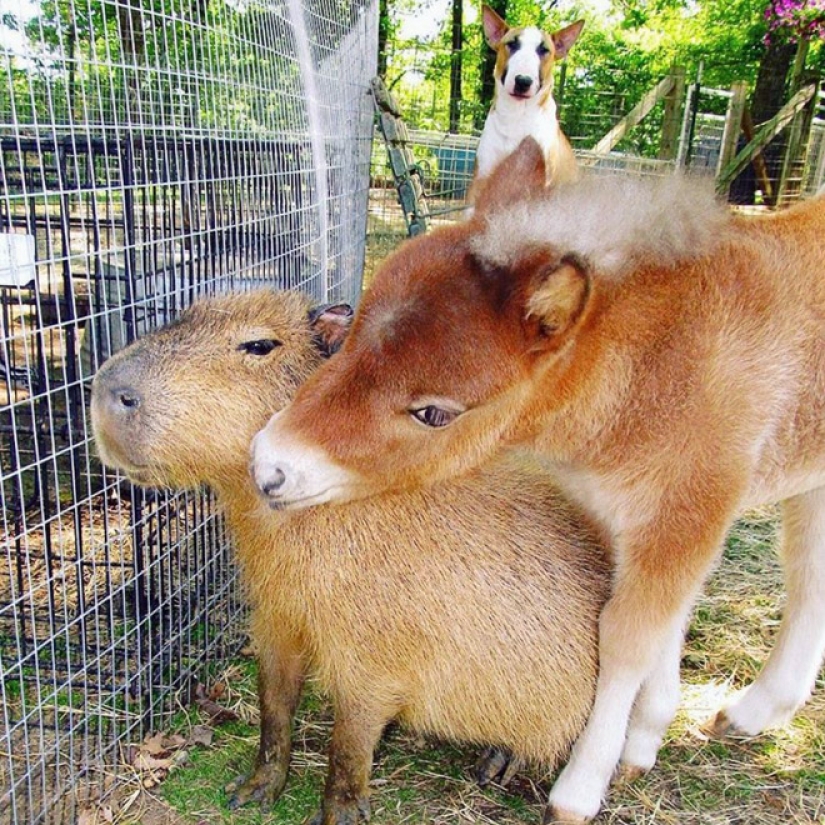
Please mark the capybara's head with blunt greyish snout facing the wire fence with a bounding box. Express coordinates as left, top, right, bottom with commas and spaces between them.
91, 290, 351, 487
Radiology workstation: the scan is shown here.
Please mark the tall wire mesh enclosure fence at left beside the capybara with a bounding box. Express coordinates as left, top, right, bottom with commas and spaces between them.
0, 0, 377, 825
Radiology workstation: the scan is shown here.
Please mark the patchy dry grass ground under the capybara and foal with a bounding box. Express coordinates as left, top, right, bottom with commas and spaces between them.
103, 510, 825, 825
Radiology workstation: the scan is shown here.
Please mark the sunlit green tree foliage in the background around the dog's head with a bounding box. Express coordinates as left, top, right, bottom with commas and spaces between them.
387, 0, 824, 150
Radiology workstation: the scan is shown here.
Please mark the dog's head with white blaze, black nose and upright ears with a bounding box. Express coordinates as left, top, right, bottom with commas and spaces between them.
481, 5, 584, 100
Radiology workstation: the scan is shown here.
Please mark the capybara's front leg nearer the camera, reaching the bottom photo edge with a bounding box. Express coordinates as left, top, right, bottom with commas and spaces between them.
307, 701, 394, 825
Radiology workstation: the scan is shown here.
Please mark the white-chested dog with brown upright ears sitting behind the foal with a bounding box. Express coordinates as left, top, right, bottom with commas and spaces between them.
470, 5, 584, 202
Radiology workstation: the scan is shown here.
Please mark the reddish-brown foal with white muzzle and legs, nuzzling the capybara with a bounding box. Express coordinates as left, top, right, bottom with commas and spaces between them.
255, 141, 825, 822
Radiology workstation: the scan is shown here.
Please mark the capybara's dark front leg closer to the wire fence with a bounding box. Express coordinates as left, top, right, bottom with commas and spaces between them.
227, 643, 304, 808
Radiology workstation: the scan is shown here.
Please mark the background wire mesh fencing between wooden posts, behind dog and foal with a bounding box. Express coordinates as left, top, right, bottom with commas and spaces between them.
367, 67, 825, 254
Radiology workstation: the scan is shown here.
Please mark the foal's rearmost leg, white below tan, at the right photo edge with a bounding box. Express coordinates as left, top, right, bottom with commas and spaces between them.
725, 488, 825, 736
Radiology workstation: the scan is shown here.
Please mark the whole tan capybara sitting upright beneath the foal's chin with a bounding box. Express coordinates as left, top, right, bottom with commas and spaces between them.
92, 291, 609, 825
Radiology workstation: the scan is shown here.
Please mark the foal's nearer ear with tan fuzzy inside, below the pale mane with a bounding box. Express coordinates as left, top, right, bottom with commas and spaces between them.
525, 255, 590, 342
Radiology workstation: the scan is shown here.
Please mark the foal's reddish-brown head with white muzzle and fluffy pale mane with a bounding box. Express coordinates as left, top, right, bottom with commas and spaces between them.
253, 139, 724, 508
